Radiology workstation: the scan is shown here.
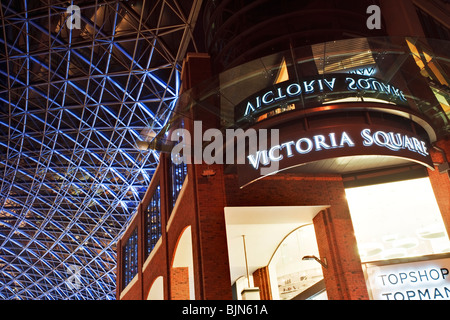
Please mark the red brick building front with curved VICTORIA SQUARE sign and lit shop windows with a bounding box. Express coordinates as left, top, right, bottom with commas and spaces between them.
119, 38, 450, 300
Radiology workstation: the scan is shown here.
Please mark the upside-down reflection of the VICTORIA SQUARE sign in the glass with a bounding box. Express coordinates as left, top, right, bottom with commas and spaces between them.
235, 74, 407, 123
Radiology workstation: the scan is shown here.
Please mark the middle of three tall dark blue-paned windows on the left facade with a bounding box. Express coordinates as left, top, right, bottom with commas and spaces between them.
145, 185, 161, 257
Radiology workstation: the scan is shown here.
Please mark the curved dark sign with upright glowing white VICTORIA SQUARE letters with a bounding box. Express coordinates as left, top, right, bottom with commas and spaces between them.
238, 123, 433, 186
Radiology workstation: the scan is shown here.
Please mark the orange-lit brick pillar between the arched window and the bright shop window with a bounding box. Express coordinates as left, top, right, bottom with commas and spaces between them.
313, 205, 369, 300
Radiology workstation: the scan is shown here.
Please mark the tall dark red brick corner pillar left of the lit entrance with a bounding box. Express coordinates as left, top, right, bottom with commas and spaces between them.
182, 54, 232, 300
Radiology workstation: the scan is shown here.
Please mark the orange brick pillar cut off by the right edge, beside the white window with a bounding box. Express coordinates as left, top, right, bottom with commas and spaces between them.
428, 140, 450, 235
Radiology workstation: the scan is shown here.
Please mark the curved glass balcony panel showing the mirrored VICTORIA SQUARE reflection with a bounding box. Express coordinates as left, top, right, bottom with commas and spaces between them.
171, 37, 450, 136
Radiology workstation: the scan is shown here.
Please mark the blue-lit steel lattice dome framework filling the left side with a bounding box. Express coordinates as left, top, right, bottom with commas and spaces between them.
0, 0, 201, 299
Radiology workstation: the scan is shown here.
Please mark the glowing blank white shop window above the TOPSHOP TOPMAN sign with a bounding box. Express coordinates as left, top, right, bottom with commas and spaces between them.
346, 178, 450, 262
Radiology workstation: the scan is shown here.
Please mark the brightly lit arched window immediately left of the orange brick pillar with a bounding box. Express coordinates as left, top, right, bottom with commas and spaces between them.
269, 225, 326, 300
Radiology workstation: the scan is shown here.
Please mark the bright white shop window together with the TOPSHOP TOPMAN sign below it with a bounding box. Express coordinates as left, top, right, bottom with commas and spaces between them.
346, 178, 450, 300
